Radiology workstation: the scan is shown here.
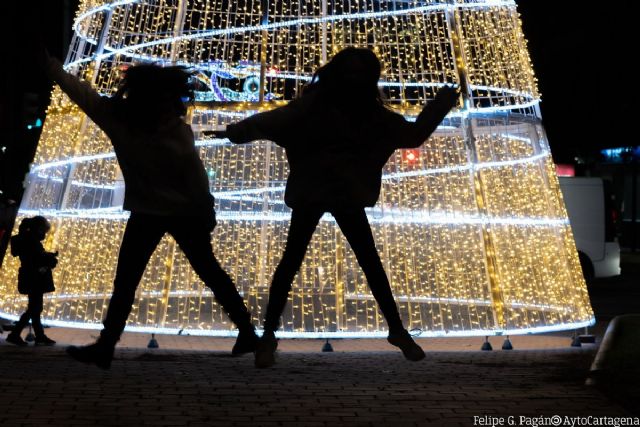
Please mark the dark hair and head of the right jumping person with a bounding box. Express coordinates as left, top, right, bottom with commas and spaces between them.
302, 47, 382, 106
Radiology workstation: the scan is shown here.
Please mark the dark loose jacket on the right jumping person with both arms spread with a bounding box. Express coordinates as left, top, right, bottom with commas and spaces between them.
227, 93, 452, 209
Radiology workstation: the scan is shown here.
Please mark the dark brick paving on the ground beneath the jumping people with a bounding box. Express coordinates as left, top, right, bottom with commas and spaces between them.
0, 328, 630, 427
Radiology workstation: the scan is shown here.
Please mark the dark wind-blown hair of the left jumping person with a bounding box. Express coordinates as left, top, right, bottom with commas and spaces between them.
115, 65, 193, 129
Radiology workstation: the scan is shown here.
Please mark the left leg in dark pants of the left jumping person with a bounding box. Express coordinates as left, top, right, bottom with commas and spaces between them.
100, 213, 165, 346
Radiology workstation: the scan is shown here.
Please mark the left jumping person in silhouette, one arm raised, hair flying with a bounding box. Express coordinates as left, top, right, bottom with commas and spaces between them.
41, 55, 257, 369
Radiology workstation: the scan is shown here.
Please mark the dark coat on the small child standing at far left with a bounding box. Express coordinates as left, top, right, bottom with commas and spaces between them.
11, 231, 58, 294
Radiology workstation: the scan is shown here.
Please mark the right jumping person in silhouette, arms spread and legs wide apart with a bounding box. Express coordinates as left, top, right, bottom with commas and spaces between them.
214, 48, 458, 367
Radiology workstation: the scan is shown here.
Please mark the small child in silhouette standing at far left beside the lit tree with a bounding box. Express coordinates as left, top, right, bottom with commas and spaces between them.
7, 216, 58, 347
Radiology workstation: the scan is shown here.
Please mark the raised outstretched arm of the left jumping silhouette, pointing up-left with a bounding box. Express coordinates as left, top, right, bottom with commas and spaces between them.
40, 49, 107, 123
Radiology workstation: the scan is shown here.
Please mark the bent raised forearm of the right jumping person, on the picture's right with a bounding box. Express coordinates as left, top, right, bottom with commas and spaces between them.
395, 86, 460, 148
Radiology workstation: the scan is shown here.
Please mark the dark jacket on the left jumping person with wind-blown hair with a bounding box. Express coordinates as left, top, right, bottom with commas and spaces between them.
47, 58, 213, 216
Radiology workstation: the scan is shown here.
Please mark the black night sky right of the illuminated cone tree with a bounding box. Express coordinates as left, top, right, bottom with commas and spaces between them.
517, 0, 638, 162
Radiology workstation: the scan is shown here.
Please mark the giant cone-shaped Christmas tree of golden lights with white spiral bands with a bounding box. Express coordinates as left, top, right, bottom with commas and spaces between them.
0, 0, 594, 337
